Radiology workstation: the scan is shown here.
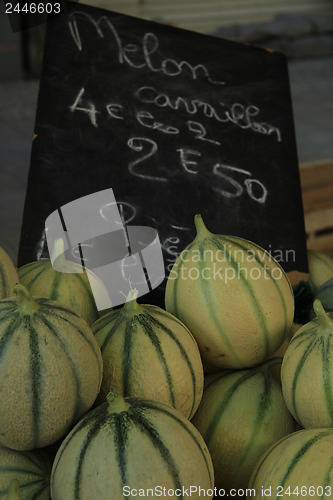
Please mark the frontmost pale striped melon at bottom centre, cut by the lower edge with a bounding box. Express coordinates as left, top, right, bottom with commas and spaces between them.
51, 393, 214, 500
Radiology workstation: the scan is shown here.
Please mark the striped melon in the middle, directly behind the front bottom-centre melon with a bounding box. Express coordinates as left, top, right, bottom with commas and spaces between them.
91, 290, 203, 418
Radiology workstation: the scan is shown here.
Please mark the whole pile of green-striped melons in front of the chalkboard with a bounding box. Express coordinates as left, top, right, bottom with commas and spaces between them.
0, 215, 333, 500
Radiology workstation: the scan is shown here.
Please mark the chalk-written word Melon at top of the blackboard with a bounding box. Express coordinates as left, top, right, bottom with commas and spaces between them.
68, 11, 225, 85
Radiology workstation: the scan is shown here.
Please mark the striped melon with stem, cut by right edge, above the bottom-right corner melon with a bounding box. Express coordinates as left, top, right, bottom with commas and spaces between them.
281, 299, 333, 428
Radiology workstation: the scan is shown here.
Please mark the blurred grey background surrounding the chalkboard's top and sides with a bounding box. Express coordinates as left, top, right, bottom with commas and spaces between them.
0, 0, 333, 262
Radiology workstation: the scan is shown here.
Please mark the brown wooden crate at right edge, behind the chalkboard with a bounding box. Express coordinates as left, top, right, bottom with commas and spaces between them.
300, 160, 333, 256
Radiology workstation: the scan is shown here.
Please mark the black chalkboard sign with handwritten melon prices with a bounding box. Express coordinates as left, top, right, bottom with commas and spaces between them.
18, 0, 307, 304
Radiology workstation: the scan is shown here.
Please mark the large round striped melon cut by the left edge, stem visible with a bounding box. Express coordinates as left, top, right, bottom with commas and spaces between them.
0, 284, 102, 450
